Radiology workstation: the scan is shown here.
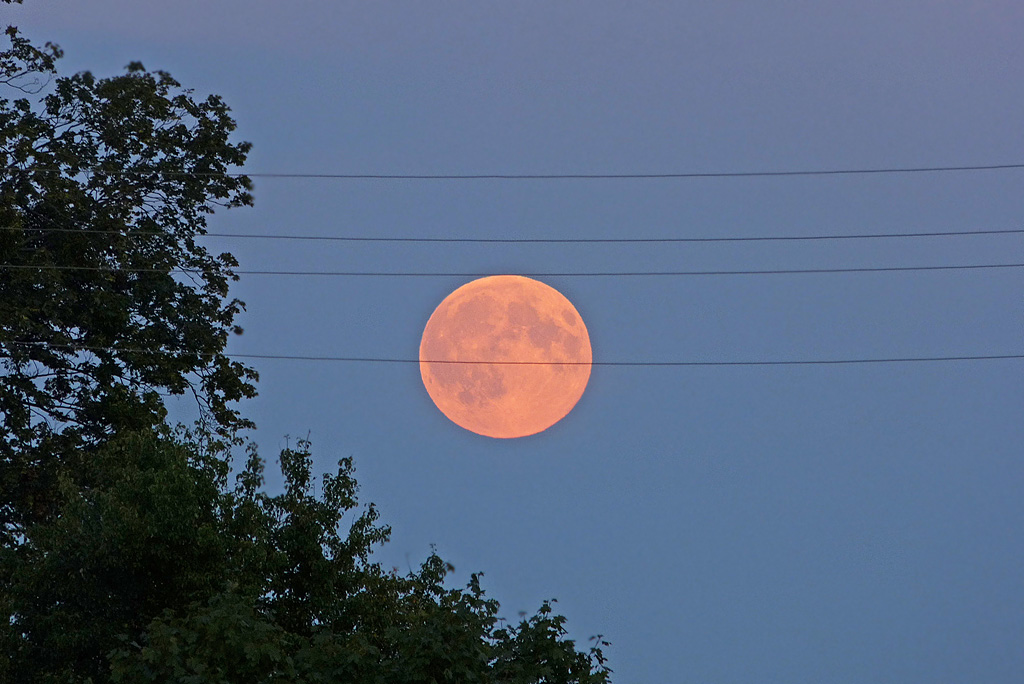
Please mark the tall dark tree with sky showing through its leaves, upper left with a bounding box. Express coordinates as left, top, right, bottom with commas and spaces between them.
0, 18, 256, 540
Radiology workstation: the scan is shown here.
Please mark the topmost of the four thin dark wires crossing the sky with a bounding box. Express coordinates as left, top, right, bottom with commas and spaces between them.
5, 164, 1024, 180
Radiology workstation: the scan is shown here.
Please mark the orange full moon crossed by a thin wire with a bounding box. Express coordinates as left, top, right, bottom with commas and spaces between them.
420, 275, 592, 438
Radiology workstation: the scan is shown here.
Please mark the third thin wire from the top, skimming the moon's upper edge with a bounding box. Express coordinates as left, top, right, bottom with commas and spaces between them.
0, 263, 1024, 277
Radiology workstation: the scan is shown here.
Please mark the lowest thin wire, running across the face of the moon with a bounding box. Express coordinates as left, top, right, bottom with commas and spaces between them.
0, 341, 1024, 367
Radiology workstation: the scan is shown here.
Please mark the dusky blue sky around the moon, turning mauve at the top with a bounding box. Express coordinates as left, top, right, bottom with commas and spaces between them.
9, 0, 1024, 684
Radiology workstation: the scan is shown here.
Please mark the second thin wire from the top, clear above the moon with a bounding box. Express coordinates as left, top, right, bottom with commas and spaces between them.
0, 226, 1024, 245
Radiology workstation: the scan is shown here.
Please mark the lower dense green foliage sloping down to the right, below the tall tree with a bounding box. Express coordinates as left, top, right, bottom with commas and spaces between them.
0, 432, 608, 684
